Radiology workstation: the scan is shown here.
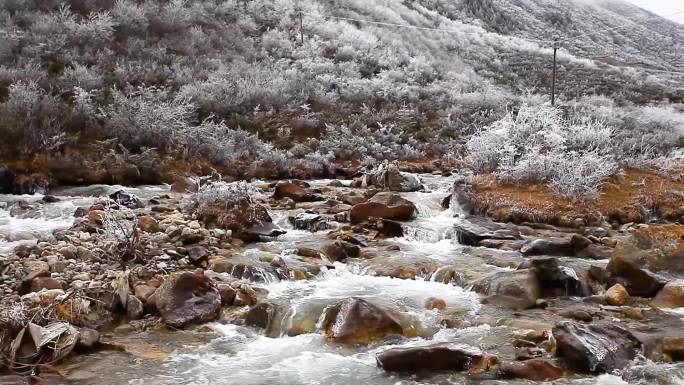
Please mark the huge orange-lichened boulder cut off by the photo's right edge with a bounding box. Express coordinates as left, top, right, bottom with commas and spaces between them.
607, 225, 684, 297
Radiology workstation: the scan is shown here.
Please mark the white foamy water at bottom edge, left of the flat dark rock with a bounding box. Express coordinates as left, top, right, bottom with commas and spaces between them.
162, 325, 418, 385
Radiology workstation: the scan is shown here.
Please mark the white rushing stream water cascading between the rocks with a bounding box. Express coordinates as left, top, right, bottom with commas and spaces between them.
5, 176, 684, 385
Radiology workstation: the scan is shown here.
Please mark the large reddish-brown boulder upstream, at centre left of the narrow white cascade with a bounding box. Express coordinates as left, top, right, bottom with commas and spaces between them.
350, 192, 416, 223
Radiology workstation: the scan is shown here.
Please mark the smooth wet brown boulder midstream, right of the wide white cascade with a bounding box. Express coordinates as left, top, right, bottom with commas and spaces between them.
473, 269, 541, 309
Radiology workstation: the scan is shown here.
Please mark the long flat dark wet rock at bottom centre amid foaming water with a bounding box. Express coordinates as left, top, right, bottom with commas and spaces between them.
376, 343, 486, 372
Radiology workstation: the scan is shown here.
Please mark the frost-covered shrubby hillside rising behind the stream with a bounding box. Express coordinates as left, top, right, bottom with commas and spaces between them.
0, 0, 684, 195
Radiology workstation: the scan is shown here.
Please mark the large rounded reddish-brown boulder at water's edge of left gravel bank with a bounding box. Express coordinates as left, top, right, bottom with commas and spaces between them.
154, 272, 221, 328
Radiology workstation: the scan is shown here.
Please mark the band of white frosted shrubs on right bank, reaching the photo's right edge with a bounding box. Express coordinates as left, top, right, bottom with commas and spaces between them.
466, 105, 684, 198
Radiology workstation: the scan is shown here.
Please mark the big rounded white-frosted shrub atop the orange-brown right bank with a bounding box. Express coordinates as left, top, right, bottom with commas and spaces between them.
467, 105, 618, 197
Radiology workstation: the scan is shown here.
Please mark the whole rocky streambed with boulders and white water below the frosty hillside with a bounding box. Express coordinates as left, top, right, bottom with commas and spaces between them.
0, 169, 684, 384
